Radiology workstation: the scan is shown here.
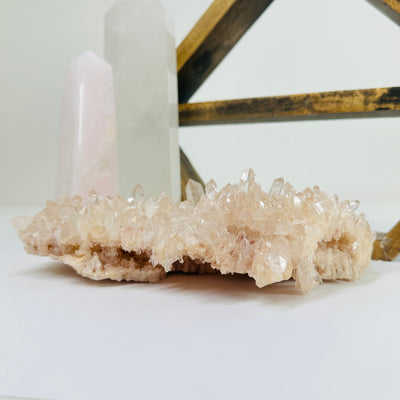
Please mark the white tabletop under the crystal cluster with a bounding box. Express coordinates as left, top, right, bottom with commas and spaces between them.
0, 203, 400, 399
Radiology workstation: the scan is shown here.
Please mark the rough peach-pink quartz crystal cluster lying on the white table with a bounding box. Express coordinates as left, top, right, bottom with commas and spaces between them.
14, 170, 373, 293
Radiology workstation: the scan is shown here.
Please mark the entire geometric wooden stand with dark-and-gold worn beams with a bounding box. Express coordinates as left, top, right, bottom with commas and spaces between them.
177, 0, 400, 261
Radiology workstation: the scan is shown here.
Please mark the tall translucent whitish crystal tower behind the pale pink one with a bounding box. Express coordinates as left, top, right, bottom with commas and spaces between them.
105, 0, 180, 201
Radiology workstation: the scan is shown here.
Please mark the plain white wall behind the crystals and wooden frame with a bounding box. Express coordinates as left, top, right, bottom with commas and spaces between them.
0, 0, 400, 205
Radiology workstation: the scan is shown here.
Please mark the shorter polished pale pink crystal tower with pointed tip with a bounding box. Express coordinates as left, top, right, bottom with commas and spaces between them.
56, 51, 119, 199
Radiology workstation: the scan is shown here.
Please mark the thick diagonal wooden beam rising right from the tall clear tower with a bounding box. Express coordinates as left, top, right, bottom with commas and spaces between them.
177, 0, 272, 103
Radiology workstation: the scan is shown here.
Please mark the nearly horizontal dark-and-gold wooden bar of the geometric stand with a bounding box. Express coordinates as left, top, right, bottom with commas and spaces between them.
179, 87, 400, 126
